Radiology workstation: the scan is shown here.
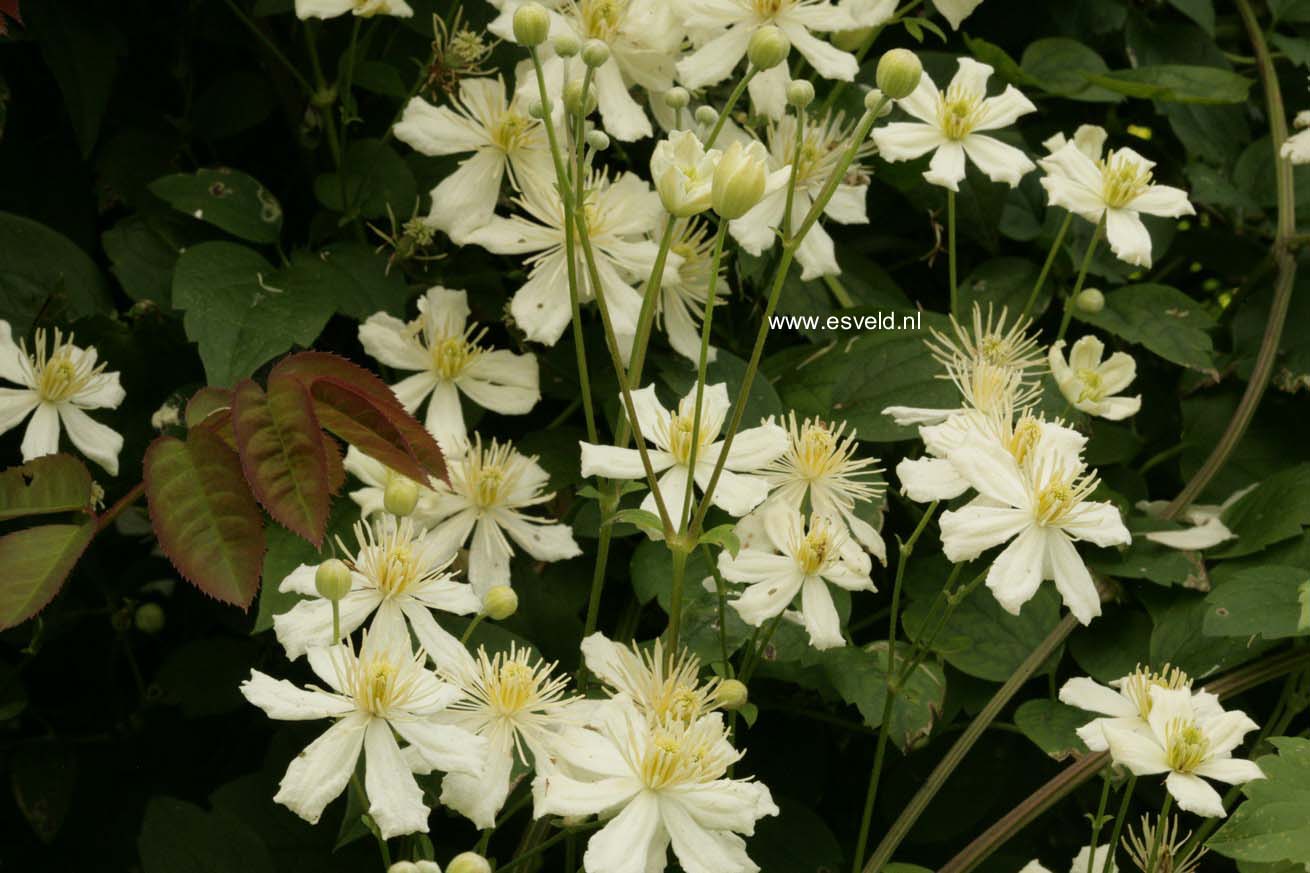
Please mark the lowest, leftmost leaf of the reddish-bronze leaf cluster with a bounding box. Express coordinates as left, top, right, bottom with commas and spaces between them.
144, 429, 263, 610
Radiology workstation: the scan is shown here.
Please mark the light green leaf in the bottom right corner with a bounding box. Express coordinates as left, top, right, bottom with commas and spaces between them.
1207, 737, 1310, 864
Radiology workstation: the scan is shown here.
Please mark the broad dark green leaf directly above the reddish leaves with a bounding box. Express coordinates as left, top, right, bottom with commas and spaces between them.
173, 243, 335, 387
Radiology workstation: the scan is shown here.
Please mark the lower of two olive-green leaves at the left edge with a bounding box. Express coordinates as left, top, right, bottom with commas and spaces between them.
0, 520, 96, 631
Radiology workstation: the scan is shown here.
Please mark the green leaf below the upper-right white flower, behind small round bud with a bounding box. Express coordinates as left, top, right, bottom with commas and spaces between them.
1074, 284, 1214, 372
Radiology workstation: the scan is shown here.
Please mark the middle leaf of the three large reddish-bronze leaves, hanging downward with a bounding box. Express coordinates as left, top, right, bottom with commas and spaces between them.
232, 376, 331, 545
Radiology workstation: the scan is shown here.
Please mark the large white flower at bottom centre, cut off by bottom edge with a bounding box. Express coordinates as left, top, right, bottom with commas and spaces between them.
533, 697, 778, 873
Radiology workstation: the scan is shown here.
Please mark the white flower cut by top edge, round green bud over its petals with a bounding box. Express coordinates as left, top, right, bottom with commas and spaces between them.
677, 0, 859, 118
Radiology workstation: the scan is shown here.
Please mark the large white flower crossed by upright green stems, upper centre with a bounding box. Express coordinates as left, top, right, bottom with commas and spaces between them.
468, 173, 680, 354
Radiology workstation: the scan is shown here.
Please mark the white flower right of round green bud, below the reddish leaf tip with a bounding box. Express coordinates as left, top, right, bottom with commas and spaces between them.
427, 437, 582, 596
